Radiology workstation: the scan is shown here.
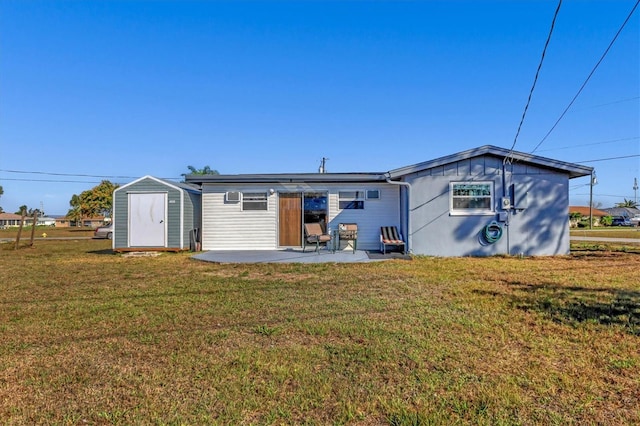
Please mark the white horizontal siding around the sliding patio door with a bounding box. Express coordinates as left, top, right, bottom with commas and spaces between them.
202, 183, 400, 250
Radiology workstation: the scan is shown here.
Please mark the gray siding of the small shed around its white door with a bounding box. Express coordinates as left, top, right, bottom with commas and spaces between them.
113, 178, 200, 249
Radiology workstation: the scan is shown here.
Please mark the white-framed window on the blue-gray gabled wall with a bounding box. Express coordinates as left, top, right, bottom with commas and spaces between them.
449, 182, 493, 214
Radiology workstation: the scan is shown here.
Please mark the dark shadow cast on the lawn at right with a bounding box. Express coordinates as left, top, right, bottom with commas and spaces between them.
474, 282, 640, 336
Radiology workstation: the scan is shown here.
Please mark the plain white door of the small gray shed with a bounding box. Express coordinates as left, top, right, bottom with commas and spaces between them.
129, 193, 167, 247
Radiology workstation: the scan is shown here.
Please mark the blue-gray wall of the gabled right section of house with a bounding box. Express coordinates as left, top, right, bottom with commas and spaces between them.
405, 156, 569, 256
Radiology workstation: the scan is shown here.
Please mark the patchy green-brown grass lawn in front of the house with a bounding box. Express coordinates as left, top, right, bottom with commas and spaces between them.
0, 240, 640, 425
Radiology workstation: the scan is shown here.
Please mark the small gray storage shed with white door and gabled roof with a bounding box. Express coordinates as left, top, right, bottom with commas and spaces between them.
112, 176, 201, 251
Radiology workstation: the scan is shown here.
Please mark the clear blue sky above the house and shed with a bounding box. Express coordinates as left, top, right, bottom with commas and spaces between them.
0, 0, 640, 214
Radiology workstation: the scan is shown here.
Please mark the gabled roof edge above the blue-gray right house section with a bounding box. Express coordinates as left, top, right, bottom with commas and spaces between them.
389, 145, 593, 179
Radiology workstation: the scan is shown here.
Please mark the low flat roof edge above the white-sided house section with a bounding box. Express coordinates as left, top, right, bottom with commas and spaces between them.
185, 173, 385, 184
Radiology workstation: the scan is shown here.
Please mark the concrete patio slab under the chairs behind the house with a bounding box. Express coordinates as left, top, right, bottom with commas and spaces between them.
193, 249, 411, 263
